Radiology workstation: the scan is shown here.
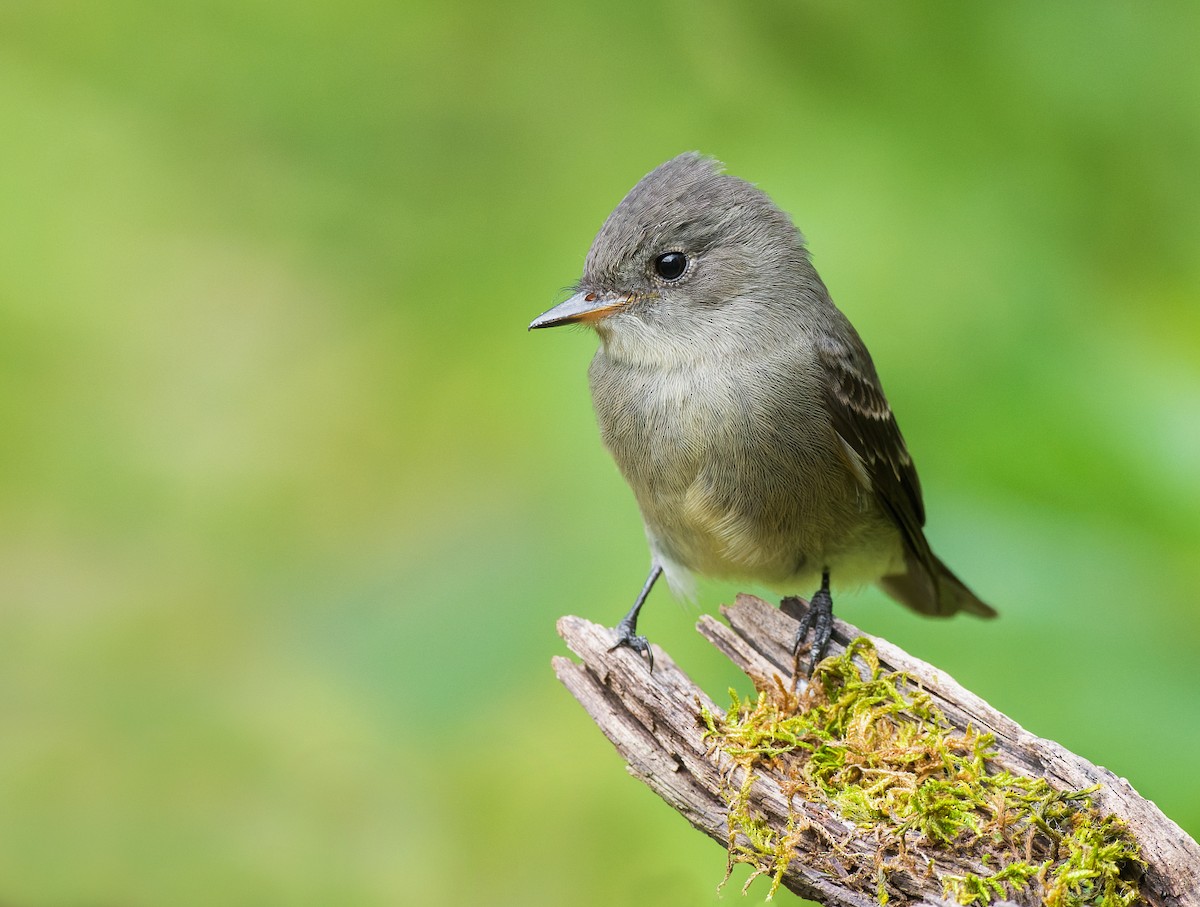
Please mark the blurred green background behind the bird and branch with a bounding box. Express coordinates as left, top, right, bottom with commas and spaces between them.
0, 0, 1200, 905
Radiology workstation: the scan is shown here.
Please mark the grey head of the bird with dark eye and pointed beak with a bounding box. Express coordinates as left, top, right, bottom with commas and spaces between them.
529, 152, 815, 359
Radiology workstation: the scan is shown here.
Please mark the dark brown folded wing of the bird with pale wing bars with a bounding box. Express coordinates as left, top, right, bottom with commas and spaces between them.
817, 338, 937, 587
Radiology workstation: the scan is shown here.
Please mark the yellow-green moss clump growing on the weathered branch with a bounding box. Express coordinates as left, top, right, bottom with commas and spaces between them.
703, 638, 1142, 907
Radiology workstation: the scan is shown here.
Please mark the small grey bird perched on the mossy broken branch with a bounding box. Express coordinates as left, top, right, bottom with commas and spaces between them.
529, 152, 996, 673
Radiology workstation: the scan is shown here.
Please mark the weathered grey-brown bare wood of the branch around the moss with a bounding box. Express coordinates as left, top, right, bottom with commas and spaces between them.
554, 595, 1200, 907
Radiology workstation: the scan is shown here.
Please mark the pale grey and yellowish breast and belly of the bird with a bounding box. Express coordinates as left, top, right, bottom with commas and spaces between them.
590, 352, 894, 584
